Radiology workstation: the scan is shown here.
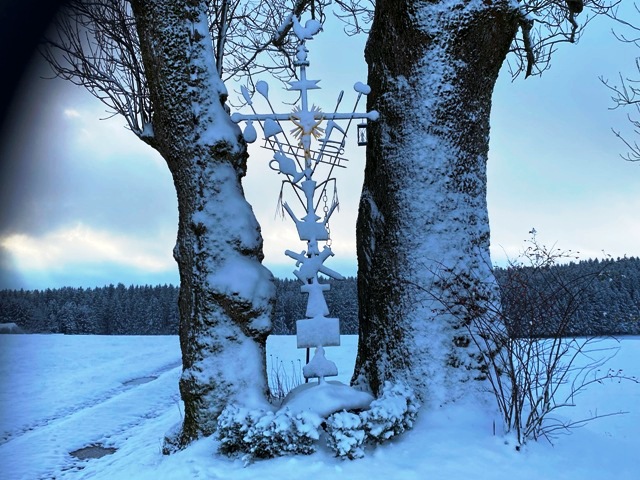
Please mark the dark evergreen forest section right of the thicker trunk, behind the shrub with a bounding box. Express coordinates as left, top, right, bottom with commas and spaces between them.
494, 257, 640, 336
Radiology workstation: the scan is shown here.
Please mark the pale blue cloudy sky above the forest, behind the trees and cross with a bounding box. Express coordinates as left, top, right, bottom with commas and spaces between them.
0, 6, 640, 289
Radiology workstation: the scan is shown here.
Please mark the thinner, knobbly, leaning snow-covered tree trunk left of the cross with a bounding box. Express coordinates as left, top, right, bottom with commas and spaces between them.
132, 0, 275, 445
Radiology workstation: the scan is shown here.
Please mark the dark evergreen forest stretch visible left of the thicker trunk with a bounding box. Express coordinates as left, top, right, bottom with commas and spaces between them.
0, 277, 358, 335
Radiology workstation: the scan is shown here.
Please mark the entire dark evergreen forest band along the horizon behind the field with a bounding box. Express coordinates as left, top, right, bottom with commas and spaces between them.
0, 258, 640, 336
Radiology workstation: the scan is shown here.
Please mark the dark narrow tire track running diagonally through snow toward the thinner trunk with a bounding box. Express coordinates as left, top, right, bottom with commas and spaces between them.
0, 361, 182, 446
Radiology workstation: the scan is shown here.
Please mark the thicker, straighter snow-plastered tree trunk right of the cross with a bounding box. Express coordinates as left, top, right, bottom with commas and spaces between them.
354, 0, 518, 406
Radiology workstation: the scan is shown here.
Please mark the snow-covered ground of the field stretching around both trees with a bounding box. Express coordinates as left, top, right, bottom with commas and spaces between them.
0, 335, 640, 480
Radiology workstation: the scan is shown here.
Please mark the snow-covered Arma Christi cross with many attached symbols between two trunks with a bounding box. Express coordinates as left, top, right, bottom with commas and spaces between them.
231, 16, 378, 382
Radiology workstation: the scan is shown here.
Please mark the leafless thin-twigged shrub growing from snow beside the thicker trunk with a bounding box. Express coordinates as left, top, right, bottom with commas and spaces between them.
418, 230, 638, 446
